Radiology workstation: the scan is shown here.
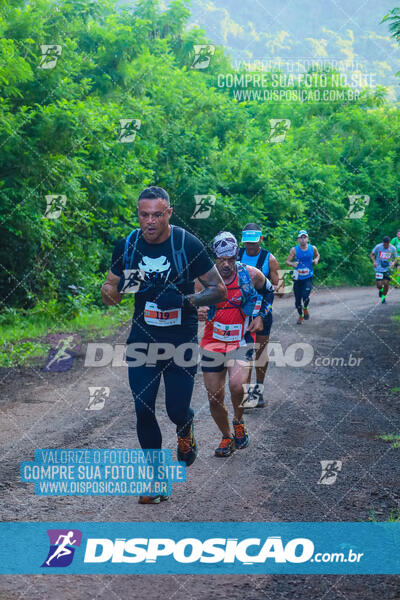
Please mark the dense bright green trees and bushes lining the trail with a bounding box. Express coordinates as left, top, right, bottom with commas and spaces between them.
0, 0, 400, 328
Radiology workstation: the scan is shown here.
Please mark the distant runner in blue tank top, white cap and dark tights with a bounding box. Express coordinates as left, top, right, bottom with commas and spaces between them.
286, 229, 320, 325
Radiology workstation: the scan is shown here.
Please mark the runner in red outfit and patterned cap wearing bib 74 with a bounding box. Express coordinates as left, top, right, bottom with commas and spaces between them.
196, 231, 274, 457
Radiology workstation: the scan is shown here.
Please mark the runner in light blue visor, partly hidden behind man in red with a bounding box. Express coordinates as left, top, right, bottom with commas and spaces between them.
238, 223, 283, 408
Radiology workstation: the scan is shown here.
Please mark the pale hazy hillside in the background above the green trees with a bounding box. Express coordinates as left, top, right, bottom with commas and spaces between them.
191, 0, 400, 100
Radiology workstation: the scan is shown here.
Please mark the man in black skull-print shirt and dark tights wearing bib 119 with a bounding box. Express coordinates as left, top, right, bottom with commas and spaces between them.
101, 186, 226, 504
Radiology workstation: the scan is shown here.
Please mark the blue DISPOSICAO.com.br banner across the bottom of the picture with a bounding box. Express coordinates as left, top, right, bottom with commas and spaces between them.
0, 522, 400, 575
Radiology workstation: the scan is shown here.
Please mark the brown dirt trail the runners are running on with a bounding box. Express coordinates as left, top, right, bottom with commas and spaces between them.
0, 288, 400, 600
